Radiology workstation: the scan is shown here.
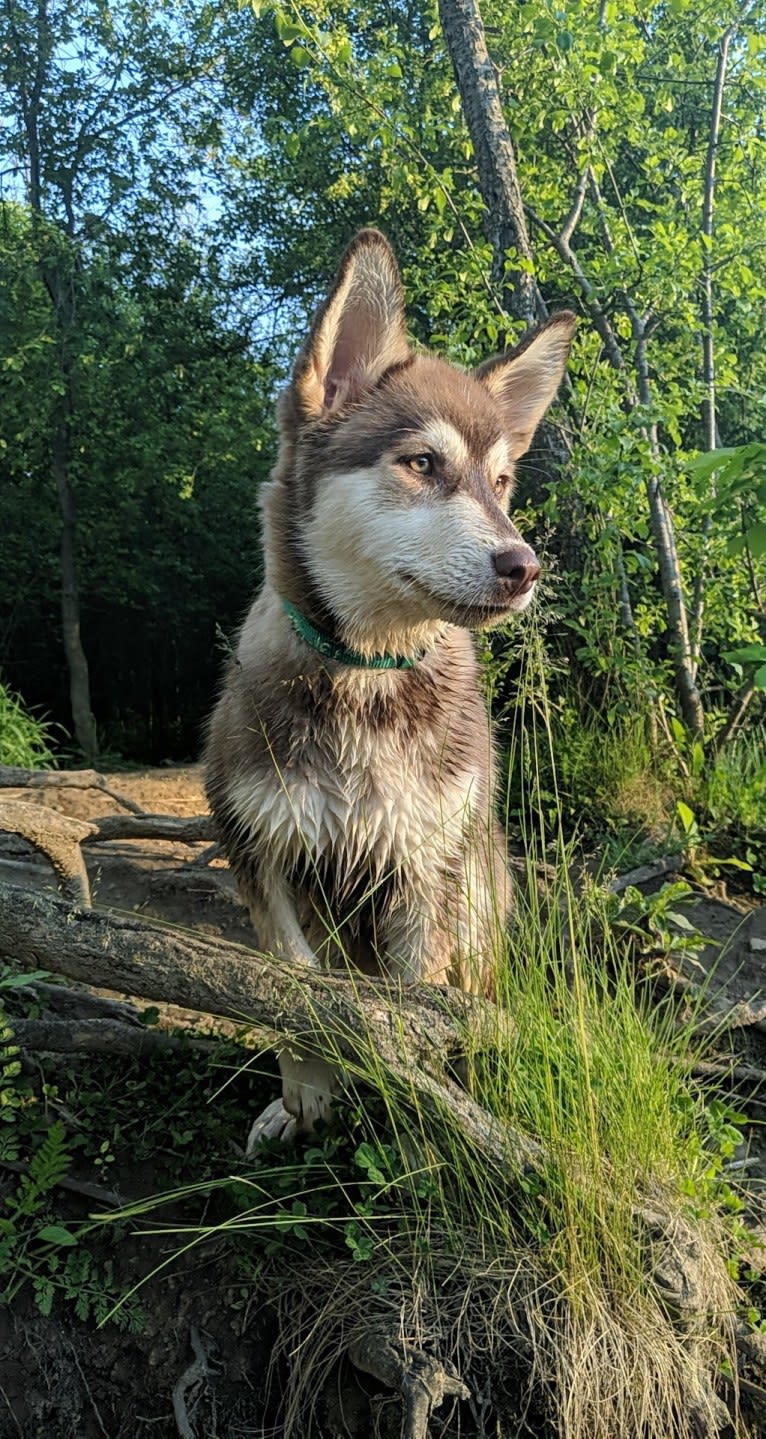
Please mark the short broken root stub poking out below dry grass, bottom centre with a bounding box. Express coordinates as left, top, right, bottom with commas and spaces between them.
348, 1333, 471, 1439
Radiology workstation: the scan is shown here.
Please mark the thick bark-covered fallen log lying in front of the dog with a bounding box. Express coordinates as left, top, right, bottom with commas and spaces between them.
0, 882, 539, 1171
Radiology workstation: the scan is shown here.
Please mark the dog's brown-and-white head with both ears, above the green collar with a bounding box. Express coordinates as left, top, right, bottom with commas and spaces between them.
265, 230, 575, 653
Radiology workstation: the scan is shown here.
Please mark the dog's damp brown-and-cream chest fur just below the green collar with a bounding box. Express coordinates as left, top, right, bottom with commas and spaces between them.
207, 592, 491, 889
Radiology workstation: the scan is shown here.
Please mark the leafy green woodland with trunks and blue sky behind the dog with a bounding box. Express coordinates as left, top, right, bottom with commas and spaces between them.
0, 0, 766, 758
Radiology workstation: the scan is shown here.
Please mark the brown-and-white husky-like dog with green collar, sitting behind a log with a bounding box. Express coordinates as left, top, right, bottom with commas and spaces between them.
206, 229, 575, 1150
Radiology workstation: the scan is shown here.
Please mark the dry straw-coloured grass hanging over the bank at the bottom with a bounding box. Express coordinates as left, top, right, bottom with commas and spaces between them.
264, 1220, 742, 1439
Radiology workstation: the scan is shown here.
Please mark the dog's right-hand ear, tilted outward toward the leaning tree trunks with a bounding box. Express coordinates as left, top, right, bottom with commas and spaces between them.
474, 309, 577, 459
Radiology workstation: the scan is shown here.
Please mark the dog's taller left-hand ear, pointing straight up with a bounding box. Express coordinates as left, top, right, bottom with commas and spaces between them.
292, 230, 409, 420
